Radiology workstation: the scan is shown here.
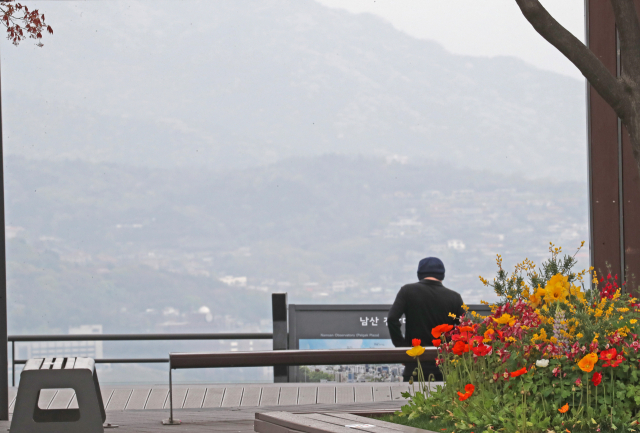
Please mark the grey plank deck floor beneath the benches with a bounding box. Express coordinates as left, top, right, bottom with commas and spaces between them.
0, 383, 430, 433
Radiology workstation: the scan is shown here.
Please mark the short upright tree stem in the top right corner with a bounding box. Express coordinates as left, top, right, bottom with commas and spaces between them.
611, 0, 640, 85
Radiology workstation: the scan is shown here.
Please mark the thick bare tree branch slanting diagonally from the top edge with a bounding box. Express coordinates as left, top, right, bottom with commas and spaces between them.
516, 0, 627, 118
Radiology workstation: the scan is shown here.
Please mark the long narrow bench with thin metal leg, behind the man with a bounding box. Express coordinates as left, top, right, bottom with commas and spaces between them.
162, 347, 438, 424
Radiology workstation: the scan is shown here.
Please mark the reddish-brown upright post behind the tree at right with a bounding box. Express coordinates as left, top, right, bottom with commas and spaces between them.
585, 0, 640, 289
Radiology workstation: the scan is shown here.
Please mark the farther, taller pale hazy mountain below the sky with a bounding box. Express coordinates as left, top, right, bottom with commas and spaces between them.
2, 0, 586, 181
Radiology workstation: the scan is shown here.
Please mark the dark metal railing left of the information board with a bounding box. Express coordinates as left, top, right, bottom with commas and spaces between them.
7, 332, 273, 386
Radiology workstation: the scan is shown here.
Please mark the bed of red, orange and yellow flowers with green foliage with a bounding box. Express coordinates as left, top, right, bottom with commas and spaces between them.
394, 245, 640, 432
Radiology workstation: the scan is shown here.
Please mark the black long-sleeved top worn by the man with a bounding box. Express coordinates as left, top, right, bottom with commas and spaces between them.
387, 280, 464, 347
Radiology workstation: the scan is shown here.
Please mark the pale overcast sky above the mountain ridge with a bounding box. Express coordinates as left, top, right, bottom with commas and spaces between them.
317, 0, 584, 78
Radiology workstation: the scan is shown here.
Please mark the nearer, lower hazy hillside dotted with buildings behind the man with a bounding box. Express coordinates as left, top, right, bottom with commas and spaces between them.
6, 155, 587, 332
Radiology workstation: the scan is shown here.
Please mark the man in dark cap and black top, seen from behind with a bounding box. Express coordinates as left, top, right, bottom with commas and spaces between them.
387, 257, 464, 382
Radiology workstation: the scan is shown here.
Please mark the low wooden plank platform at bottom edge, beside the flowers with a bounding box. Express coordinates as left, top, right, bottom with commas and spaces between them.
253, 412, 434, 433
